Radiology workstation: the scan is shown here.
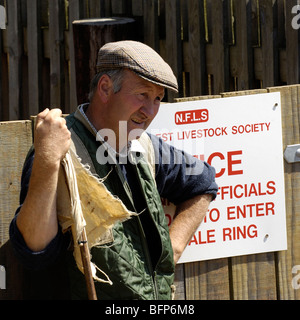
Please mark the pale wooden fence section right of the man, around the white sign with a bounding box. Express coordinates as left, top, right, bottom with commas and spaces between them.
176, 85, 300, 300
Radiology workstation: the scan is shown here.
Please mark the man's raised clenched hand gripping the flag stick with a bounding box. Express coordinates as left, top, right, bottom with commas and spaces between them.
34, 109, 71, 167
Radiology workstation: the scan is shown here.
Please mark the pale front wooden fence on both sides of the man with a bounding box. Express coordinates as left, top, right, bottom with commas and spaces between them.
0, 85, 300, 300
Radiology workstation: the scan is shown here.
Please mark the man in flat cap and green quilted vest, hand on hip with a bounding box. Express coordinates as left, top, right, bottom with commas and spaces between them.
10, 41, 217, 299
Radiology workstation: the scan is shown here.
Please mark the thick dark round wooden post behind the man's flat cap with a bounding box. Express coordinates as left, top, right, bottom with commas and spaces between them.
73, 18, 139, 104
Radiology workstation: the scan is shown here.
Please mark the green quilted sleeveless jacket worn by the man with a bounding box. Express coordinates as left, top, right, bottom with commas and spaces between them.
66, 106, 175, 300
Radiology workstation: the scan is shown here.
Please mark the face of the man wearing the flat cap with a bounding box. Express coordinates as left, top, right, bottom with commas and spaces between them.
105, 70, 164, 145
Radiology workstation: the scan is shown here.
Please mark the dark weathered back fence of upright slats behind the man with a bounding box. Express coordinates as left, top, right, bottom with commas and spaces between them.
0, 0, 300, 120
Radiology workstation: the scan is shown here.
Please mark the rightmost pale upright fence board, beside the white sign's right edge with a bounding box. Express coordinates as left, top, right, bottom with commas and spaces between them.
268, 85, 300, 300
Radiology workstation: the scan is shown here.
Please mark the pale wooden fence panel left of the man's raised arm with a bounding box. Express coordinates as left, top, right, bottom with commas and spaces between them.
0, 121, 70, 300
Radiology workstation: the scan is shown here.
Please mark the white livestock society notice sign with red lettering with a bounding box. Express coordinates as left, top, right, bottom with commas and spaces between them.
148, 93, 287, 263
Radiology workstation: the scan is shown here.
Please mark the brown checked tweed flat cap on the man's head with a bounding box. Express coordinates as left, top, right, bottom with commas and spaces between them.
97, 40, 178, 92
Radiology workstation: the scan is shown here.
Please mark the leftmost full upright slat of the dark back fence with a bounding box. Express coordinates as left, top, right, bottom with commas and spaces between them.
6, 0, 23, 120
